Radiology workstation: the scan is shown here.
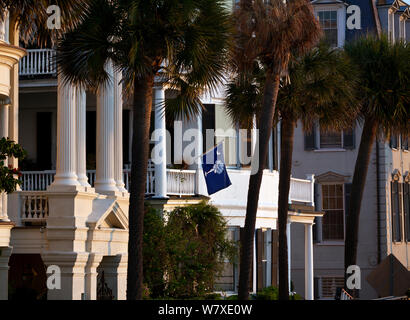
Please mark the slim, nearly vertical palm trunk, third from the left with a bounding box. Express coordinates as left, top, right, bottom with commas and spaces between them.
278, 116, 295, 300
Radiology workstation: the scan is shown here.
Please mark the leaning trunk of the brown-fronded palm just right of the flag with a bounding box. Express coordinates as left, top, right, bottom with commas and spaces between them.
238, 72, 280, 300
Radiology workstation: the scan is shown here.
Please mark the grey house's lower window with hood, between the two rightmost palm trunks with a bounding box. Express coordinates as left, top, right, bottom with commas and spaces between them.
322, 184, 344, 241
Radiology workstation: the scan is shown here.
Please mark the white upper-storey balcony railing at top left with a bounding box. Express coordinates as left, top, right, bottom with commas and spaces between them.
19, 49, 57, 76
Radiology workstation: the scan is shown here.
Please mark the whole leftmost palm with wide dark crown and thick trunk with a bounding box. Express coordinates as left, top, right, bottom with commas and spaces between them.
58, 0, 230, 300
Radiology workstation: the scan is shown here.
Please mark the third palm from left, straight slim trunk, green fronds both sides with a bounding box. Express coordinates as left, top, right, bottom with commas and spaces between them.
226, 43, 357, 300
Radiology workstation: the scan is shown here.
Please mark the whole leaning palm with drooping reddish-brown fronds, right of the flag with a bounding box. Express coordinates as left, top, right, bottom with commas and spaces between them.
232, 0, 320, 300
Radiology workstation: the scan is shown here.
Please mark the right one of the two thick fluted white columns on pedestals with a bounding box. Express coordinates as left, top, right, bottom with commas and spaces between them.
94, 63, 118, 194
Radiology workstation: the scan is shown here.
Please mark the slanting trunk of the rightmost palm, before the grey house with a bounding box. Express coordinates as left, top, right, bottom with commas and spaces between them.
345, 119, 377, 296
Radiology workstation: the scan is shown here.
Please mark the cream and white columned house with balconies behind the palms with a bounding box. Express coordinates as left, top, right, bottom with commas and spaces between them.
0, 3, 322, 300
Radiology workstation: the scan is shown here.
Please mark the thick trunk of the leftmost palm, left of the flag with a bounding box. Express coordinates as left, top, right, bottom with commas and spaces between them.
127, 76, 154, 300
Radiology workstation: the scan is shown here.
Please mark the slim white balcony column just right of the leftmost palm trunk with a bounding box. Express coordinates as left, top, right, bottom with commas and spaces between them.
153, 84, 167, 198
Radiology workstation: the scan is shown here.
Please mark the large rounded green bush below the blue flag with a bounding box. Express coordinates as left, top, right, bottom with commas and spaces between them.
144, 202, 237, 298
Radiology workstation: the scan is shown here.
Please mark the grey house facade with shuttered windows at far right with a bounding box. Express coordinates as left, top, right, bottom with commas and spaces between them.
291, 1, 410, 299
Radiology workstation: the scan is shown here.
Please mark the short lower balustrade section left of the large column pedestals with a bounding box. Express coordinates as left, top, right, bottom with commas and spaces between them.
20, 191, 49, 223
